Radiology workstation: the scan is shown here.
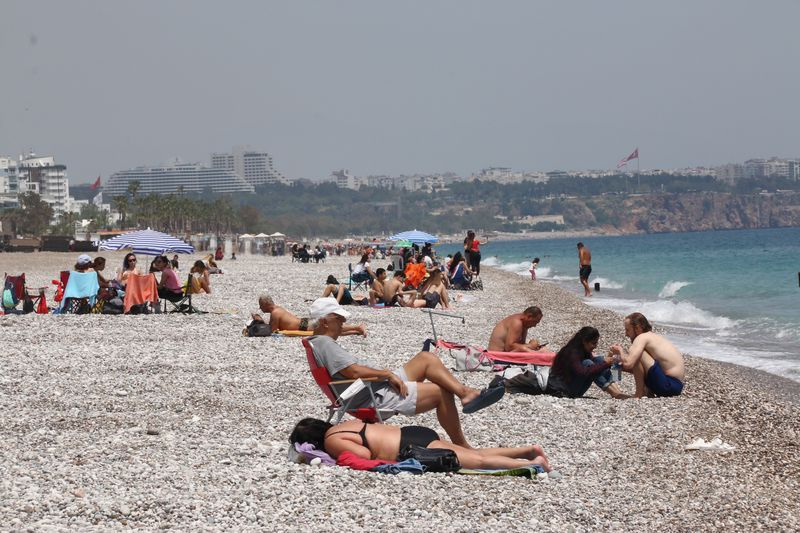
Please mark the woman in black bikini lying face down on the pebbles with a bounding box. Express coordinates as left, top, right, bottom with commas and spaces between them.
289, 418, 550, 471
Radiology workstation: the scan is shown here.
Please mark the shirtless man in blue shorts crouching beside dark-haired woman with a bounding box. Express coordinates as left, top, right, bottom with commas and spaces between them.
611, 313, 686, 398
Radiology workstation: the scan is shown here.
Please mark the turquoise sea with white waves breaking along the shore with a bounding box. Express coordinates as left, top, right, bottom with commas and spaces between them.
437, 228, 800, 381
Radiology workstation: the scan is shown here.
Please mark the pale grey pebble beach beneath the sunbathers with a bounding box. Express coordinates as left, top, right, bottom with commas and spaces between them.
0, 253, 800, 531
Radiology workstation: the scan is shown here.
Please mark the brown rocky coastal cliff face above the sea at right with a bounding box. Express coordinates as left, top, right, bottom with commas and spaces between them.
561, 192, 800, 233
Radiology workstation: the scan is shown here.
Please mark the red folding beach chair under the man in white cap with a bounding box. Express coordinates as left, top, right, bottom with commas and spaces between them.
302, 339, 396, 424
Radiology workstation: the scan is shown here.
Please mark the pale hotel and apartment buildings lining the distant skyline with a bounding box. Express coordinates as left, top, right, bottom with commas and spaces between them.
0, 146, 800, 223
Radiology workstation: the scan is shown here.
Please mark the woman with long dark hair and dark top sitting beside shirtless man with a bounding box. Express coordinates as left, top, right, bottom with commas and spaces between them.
547, 326, 627, 398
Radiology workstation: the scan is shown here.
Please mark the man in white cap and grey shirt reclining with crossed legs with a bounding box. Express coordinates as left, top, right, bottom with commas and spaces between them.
308, 298, 505, 447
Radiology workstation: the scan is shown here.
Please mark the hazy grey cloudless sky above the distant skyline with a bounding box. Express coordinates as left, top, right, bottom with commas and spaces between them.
0, 0, 800, 184
